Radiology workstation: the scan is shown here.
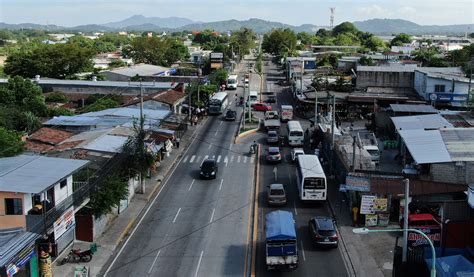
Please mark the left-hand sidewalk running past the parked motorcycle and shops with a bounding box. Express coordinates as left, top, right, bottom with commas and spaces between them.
53, 122, 202, 277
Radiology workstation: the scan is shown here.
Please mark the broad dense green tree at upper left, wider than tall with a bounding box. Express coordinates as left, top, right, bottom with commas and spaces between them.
4, 43, 95, 79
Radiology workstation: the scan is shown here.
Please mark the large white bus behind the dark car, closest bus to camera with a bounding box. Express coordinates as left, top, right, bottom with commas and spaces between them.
296, 155, 327, 201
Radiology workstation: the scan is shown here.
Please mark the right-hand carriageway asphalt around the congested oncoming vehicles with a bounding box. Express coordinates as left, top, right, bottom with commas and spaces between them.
256, 57, 347, 276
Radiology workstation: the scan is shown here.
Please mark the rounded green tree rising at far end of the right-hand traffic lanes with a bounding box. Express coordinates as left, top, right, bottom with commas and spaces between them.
262, 28, 296, 57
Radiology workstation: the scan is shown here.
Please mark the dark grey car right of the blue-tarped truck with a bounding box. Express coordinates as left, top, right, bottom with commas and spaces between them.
308, 216, 339, 248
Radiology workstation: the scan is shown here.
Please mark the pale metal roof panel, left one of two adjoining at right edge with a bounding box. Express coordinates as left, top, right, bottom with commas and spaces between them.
398, 129, 451, 164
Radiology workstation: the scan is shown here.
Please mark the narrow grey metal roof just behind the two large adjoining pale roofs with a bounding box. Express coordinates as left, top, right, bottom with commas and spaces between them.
391, 114, 453, 130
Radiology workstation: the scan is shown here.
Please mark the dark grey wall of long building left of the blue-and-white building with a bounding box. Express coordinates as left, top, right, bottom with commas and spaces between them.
356, 71, 414, 88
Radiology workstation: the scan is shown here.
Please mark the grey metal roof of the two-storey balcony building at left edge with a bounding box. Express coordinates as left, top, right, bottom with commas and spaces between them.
0, 155, 89, 193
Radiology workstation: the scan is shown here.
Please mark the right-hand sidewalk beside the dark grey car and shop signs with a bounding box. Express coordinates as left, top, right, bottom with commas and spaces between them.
328, 181, 399, 277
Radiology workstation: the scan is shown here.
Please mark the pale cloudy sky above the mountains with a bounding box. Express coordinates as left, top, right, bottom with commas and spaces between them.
0, 0, 474, 27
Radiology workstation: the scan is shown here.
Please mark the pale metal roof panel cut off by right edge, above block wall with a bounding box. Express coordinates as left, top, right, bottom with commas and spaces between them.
440, 128, 474, 162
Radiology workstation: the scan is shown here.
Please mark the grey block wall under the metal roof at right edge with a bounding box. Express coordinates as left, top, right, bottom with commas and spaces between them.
430, 162, 474, 184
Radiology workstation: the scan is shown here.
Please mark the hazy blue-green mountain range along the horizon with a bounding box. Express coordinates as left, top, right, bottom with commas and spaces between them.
0, 15, 474, 35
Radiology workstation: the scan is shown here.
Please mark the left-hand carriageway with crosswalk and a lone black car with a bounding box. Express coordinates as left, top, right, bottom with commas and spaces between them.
103, 69, 255, 277
